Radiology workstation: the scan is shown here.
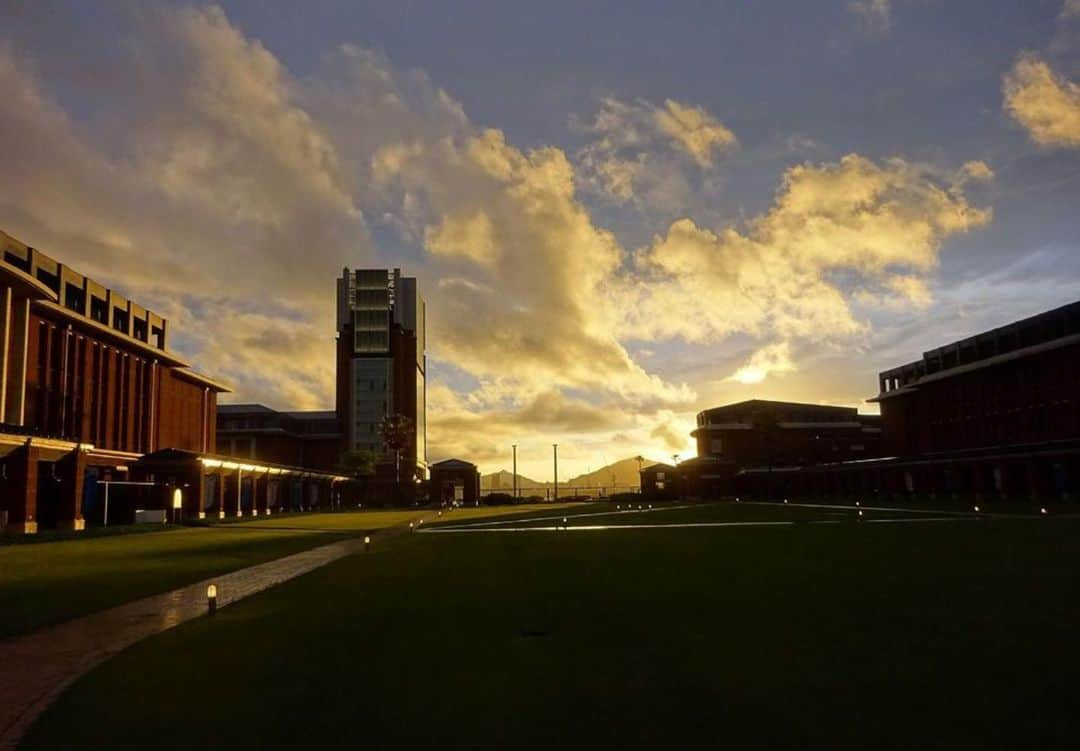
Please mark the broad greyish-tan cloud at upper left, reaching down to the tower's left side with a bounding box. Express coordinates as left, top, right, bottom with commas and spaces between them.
0, 8, 369, 406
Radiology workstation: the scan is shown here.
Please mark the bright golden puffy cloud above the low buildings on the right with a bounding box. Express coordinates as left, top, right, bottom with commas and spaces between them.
622, 155, 991, 378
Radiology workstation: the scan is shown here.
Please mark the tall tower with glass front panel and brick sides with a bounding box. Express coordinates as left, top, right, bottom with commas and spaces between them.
337, 268, 428, 478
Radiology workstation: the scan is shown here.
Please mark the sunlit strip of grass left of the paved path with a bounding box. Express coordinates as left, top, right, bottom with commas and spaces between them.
0, 506, 591, 639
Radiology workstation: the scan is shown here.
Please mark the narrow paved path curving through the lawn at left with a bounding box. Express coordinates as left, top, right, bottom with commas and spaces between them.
0, 538, 373, 751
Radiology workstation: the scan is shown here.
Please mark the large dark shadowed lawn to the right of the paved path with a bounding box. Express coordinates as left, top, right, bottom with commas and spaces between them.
24, 504, 1080, 749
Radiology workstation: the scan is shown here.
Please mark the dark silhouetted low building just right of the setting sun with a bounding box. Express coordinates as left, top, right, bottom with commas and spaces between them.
675, 399, 881, 497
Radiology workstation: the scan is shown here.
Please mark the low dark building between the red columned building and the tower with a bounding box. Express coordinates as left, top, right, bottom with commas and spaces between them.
217, 404, 345, 472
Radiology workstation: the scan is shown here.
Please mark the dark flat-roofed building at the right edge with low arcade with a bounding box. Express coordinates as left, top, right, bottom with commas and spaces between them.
739, 301, 1080, 501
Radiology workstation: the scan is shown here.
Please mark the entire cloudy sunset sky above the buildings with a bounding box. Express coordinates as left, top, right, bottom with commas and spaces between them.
0, 0, 1080, 480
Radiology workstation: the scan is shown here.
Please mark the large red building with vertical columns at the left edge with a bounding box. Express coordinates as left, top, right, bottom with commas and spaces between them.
0, 232, 228, 533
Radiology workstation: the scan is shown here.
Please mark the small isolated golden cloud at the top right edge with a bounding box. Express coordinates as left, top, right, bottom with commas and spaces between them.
1002, 55, 1080, 147
